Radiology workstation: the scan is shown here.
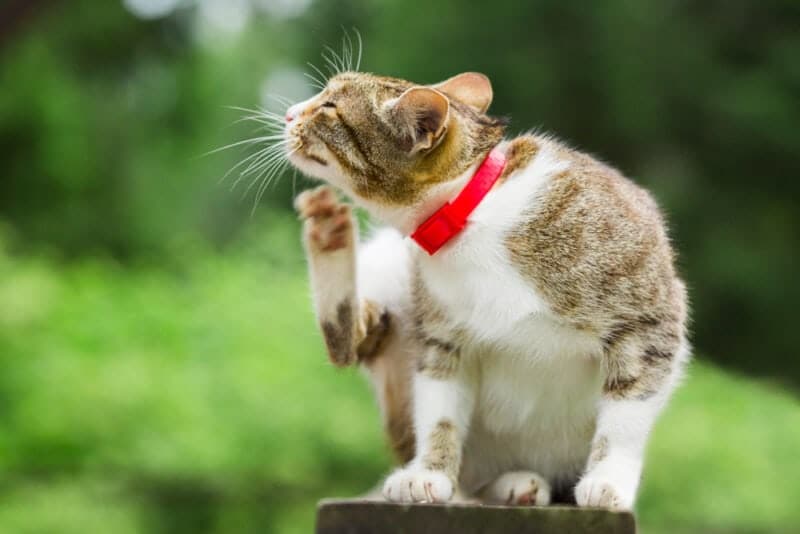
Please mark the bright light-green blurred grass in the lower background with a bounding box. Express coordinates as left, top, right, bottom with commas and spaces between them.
0, 218, 800, 534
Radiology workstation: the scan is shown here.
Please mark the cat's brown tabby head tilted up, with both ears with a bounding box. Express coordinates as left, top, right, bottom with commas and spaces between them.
285, 72, 504, 206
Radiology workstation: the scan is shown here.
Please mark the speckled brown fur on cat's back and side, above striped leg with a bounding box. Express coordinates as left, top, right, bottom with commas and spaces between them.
504, 138, 686, 331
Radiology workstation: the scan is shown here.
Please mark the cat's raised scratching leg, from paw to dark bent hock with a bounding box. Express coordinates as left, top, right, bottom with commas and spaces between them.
295, 186, 389, 365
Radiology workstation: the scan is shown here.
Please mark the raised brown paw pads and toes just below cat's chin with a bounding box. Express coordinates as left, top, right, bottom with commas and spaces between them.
294, 185, 354, 252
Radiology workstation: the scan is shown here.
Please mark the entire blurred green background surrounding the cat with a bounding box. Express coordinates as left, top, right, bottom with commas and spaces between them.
0, 0, 800, 533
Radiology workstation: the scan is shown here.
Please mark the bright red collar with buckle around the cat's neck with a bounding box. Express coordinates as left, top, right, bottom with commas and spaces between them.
411, 148, 506, 256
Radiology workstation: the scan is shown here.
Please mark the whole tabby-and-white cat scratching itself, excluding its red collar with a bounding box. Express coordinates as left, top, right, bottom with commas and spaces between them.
284, 72, 690, 510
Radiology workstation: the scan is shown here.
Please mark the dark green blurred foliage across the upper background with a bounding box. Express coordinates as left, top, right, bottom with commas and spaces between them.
0, 0, 800, 385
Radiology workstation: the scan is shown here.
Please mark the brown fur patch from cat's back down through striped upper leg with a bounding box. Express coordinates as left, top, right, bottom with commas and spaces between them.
506, 139, 686, 399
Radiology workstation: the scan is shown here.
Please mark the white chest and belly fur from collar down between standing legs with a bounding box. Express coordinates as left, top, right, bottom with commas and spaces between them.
415, 147, 600, 486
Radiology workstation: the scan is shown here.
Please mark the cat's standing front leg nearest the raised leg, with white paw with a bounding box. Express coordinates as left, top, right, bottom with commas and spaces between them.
383, 338, 475, 503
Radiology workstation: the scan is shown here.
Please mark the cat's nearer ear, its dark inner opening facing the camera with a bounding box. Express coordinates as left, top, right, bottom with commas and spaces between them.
386, 87, 450, 154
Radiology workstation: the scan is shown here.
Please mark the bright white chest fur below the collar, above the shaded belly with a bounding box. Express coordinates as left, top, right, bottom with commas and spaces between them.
416, 149, 584, 346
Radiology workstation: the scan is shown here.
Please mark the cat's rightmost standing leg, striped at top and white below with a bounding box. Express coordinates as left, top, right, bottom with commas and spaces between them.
575, 331, 688, 510
